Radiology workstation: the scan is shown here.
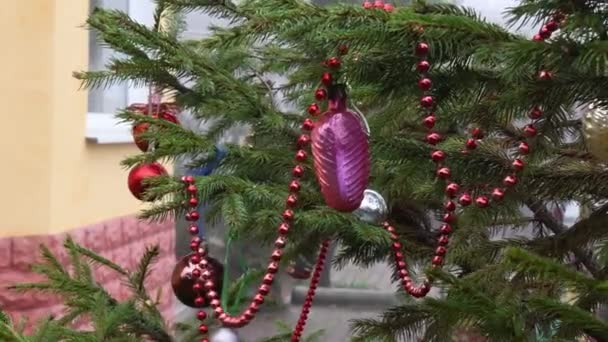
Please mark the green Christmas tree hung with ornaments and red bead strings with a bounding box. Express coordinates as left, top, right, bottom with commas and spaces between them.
2, 0, 608, 341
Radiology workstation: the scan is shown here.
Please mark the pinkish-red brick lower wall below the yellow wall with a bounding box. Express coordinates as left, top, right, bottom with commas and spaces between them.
0, 216, 175, 330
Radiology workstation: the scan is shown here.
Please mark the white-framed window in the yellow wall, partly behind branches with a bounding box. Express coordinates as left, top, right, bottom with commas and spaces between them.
86, 0, 154, 144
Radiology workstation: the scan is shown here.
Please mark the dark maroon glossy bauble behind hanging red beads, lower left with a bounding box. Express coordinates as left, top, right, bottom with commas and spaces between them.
171, 254, 224, 308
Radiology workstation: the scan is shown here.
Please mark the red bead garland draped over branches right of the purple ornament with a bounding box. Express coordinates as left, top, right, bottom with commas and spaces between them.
384, 14, 564, 298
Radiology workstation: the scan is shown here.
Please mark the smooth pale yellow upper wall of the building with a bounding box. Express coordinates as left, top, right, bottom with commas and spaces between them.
0, 0, 166, 236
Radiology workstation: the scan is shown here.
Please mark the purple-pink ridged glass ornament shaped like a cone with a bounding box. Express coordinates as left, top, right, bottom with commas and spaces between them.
312, 86, 370, 212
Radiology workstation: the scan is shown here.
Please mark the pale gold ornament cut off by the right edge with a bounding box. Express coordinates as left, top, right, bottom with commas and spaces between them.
583, 103, 608, 161
